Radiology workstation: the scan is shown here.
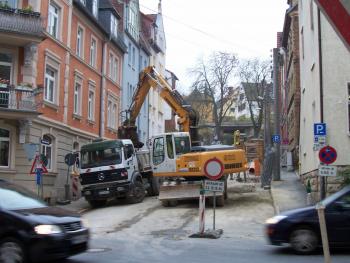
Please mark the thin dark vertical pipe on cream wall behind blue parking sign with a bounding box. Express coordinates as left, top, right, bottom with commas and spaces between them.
317, 8, 326, 200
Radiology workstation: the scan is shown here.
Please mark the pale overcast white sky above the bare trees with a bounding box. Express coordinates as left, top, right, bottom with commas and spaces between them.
139, 0, 288, 93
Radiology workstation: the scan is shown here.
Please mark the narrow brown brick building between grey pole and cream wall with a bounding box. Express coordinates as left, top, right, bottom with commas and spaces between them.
277, 0, 300, 169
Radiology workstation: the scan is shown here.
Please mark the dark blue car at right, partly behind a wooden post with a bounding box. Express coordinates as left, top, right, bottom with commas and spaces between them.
266, 186, 350, 254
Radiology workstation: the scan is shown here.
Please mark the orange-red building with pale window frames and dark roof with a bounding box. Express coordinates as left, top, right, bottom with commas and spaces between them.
0, 0, 126, 201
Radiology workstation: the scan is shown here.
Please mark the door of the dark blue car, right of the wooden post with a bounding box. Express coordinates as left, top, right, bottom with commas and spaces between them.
326, 192, 350, 245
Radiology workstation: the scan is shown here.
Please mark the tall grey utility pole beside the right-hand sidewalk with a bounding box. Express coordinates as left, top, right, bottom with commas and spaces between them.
273, 48, 281, 181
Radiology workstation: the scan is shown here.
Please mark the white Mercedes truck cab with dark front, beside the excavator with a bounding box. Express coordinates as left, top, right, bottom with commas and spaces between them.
80, 140, 145, 207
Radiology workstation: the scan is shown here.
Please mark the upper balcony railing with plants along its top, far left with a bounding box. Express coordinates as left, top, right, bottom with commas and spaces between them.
0, 7, 43, 37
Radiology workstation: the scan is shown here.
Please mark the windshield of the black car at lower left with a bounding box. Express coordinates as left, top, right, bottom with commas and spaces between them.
0, 184, 47, 210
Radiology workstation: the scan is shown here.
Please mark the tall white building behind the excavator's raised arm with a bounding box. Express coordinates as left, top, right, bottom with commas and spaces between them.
141, 1, 166, 137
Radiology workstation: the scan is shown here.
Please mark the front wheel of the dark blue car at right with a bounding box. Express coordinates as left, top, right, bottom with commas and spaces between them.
290, 227, 318, 254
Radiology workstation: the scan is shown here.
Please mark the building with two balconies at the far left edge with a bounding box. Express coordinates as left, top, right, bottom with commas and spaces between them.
0, 1, 45, 184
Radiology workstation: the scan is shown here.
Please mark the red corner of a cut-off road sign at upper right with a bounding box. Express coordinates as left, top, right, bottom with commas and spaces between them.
316, 0, 350, 49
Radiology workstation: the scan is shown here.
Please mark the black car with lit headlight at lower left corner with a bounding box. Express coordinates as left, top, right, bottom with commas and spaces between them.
0, 180, 89, 262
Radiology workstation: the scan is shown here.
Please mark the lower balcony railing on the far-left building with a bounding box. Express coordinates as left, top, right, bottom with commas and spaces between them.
0, 84, 40, 111
